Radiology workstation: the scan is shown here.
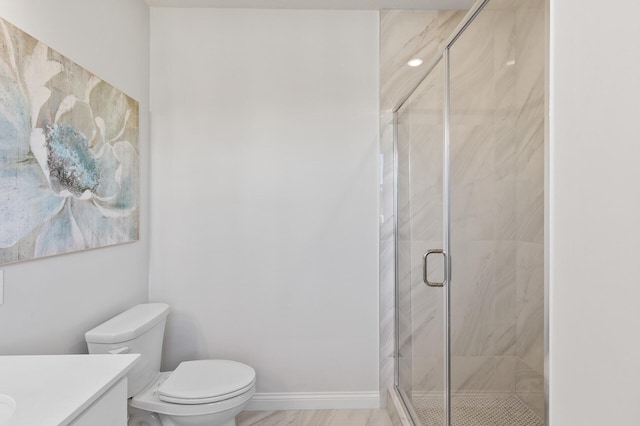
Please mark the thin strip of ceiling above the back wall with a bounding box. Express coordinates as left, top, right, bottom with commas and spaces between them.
147, 0, 475, 10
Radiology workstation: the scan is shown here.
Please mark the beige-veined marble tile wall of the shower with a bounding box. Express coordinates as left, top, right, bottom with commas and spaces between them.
380, 0, 544, 416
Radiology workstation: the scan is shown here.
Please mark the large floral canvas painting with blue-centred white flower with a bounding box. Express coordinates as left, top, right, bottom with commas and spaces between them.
0, 19, 139, 265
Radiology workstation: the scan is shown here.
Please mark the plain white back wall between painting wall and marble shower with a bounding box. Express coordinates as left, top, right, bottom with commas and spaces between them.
150, 8, 378, 400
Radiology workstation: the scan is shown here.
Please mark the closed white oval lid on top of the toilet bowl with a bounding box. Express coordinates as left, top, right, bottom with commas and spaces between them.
158, 359, 256, 404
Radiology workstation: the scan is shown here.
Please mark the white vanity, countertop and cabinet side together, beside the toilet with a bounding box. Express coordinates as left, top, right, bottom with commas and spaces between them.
0, 354, 140, 426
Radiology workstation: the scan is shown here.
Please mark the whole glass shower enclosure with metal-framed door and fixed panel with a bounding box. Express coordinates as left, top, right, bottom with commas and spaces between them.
393, 0, 545, 426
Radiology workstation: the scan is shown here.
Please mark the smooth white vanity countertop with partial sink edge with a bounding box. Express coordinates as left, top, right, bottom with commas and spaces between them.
0, 354, 140, 426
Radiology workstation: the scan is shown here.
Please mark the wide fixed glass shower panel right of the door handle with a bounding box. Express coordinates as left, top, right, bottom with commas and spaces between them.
449, 0, 544, 426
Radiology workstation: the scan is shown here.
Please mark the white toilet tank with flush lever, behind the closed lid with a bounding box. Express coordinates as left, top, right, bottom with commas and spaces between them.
84, 303, 169, 397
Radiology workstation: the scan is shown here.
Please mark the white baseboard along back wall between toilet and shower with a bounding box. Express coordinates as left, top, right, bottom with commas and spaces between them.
246, 392, 380, 411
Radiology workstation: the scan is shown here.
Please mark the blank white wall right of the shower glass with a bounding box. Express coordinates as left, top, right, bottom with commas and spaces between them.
549, 0, 640, 426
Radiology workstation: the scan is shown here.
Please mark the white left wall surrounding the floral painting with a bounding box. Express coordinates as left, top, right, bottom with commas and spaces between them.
0, 0, 149, 355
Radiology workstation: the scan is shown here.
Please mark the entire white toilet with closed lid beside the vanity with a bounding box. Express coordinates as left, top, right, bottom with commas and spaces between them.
85, 303, 256, 426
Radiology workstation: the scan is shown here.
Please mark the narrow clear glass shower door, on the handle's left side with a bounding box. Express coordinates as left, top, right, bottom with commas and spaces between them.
396, 57, 446, 426
